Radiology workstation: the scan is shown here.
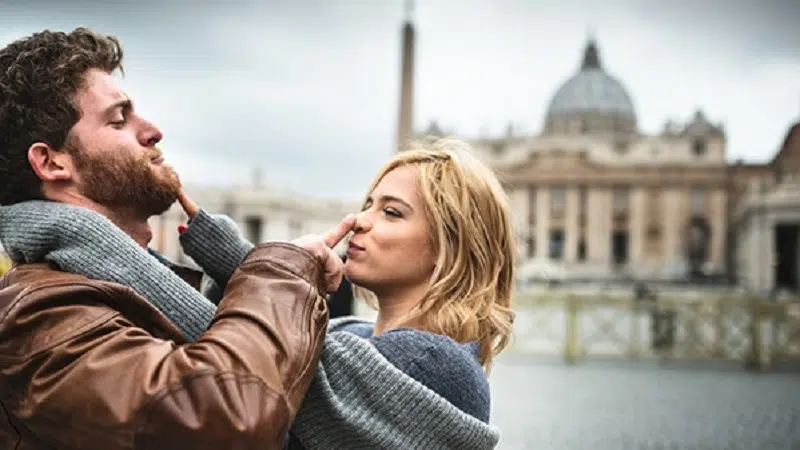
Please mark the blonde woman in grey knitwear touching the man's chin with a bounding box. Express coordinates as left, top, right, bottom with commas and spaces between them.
0, 140, 515, 449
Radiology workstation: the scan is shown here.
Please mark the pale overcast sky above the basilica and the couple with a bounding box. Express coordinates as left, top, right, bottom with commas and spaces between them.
0, 0, 800, 199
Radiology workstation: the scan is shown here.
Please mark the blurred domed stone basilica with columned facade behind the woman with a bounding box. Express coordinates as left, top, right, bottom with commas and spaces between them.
462, 40, 744, 279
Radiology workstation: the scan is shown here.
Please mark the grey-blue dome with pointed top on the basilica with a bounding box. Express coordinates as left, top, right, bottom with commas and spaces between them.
545, 39, 636, 134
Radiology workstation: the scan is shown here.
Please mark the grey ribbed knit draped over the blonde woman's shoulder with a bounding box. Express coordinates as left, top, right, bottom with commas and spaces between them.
291, 320, 500, 450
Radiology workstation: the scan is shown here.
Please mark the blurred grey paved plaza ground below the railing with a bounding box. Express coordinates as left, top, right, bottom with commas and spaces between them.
490, 351, 800, 450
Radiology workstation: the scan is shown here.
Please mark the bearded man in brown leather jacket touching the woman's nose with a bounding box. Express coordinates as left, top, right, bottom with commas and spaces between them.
0, 28, 352, 449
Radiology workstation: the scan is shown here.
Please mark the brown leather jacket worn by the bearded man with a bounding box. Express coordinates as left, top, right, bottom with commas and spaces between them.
0, 243, 328, 450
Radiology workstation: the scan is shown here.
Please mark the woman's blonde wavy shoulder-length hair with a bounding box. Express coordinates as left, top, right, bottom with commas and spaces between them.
356, 139, 516, 372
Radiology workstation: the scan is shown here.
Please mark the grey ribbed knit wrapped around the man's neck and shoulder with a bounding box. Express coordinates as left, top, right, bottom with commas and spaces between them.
0, 201, 219, 341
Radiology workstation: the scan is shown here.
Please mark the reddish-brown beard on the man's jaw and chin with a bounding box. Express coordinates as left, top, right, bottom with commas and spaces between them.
70, 141, 181, 218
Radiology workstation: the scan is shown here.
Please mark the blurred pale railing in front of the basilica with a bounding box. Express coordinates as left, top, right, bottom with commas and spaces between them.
514, 293, 800, 370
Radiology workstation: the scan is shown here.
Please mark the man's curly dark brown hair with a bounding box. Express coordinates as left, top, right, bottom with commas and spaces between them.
0, 28, 122, 205
